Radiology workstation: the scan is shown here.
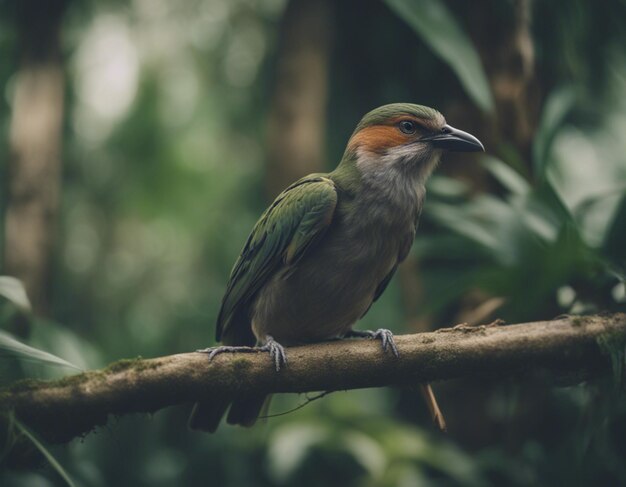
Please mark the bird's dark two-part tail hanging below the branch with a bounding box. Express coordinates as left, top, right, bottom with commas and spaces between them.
189, 395, 271, 433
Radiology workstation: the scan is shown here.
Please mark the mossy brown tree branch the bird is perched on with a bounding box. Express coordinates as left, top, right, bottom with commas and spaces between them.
0, 314, 626, 442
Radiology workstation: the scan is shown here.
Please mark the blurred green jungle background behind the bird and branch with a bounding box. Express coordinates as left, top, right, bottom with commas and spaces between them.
0, 0, 626, 487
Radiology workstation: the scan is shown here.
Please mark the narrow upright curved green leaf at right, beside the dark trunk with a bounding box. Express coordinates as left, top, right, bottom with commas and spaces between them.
532, 87, 576, 181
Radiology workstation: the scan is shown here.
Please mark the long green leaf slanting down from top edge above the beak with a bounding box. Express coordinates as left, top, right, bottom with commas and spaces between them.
385, 0, 494, 112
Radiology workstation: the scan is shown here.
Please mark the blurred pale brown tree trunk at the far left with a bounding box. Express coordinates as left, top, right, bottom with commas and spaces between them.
4, 0, 65, 320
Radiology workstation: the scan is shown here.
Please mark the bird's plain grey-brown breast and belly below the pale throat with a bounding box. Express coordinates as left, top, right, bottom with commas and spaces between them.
252, 198, 414, 345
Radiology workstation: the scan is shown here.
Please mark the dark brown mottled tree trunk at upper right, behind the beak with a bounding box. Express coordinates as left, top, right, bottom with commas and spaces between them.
442, 0, 540, 190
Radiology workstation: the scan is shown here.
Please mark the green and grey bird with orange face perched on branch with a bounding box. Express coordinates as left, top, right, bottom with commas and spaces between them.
189, 103, 484, 432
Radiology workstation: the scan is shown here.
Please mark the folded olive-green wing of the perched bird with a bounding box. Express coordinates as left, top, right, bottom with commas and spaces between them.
215, 175, 337, 342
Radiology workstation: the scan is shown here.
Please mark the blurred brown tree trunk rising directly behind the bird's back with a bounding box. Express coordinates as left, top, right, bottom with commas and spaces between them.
267, 0, 332, 198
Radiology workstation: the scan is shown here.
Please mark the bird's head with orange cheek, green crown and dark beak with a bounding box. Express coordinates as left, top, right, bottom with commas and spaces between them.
344, 103, 484, 185
